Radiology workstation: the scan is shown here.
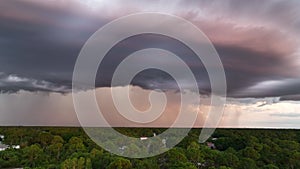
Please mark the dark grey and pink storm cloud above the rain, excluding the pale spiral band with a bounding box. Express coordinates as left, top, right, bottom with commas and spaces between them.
0, 0, 300, 99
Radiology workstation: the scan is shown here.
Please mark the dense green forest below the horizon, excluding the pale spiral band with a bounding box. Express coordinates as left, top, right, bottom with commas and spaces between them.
0, 127, 300, 169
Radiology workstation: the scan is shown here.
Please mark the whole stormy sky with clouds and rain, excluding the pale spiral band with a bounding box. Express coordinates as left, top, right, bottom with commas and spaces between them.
0, 0, 300, 128
